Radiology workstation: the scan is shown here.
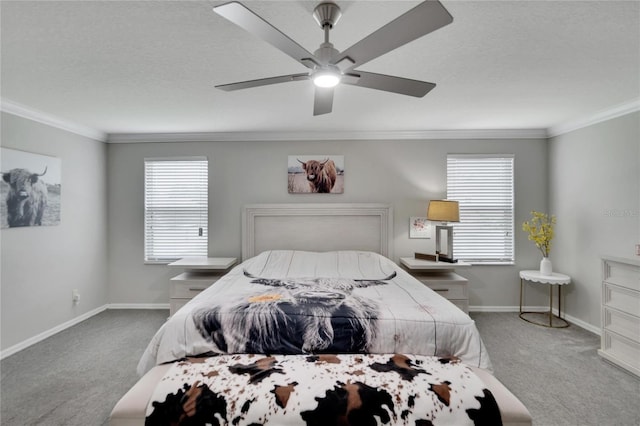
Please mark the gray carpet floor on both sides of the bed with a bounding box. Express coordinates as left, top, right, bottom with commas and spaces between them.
0, 310, 640, 426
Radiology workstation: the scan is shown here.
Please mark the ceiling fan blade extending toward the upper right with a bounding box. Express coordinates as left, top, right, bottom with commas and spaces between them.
331, 0, 453, 69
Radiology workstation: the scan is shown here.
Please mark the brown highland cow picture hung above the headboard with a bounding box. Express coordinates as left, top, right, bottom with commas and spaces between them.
287, 155, 344, 194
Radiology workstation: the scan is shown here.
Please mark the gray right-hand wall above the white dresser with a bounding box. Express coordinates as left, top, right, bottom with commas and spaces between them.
549, 112, 640, 327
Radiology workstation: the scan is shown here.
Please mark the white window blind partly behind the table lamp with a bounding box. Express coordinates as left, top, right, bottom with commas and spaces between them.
447, 154, 514, 264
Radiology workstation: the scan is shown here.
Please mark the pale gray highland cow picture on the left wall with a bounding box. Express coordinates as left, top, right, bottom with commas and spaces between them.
0, 148, 62, 228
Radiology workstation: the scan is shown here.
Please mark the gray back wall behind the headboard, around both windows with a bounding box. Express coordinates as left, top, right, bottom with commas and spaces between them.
107, 139, 548, 307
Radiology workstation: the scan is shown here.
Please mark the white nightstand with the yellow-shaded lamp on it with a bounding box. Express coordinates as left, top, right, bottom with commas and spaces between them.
400, 257, 471, 314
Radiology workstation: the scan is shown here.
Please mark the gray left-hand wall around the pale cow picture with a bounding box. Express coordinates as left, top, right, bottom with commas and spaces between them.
0, 113, 108, 350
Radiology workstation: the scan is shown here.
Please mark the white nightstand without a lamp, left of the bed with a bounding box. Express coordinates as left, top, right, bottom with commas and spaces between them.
169, 257, 237, 315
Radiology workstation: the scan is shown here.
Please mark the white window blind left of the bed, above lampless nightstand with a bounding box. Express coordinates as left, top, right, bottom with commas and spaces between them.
144, 157, 209, 263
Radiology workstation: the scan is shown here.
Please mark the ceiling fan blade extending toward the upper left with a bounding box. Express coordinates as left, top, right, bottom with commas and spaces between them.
213, 1, 317, 68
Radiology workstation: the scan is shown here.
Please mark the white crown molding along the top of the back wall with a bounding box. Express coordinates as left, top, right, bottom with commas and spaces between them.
107, 129, 547, 143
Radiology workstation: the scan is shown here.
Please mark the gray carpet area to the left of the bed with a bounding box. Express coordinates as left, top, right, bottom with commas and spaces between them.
0, 310, 169, 426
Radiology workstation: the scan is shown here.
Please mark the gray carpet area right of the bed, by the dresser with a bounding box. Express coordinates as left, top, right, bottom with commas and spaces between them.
471, 313, 640, 426
